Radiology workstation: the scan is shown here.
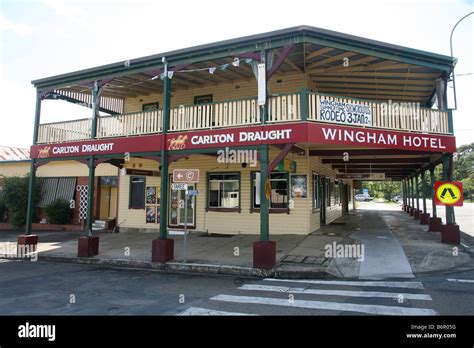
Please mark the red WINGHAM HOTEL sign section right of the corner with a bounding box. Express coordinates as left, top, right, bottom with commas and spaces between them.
308, 123, 456, 153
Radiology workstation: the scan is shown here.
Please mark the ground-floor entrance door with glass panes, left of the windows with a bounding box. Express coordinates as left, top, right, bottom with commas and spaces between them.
168, 184, 196, 227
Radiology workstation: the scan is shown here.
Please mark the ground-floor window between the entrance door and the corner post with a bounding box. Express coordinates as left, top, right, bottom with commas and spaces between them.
208, 173, 240, 209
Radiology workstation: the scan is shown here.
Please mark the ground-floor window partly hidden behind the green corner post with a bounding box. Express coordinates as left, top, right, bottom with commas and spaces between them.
252, 172, 288, 209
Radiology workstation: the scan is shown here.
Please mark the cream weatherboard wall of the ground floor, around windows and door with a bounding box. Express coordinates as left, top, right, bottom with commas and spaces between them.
118, 148, 350, 234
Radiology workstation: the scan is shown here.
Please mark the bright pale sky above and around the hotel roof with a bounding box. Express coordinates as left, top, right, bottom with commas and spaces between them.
0, 0, 474, 147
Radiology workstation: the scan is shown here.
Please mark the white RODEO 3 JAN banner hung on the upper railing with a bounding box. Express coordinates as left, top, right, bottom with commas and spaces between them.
319, 98, 372, 126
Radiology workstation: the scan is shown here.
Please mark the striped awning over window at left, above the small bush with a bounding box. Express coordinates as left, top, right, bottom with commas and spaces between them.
38, 178, 77, 208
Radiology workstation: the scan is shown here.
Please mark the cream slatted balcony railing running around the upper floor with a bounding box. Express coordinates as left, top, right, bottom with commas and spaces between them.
38, 92, 449, 143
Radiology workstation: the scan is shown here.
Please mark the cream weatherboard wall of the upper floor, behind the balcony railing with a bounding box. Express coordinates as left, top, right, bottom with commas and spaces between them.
124, 72, 307, 113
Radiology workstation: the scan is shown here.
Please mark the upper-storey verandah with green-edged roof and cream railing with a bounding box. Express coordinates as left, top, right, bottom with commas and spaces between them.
33, 26, 456, 142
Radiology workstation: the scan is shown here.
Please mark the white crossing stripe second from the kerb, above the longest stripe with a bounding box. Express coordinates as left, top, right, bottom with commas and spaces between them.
239, 284, 432, 301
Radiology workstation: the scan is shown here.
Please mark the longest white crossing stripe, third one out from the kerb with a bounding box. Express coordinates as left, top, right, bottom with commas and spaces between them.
211, 295, 437, 315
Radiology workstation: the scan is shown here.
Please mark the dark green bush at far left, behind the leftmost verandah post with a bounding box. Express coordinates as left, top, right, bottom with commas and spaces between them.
2, 176, 39, 228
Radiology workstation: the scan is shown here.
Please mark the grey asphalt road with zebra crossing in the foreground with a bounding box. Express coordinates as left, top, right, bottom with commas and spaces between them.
0, 260, 474, 315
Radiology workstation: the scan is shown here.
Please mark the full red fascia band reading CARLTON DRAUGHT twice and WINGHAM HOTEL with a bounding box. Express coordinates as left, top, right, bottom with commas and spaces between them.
30, 122, 456, 159
